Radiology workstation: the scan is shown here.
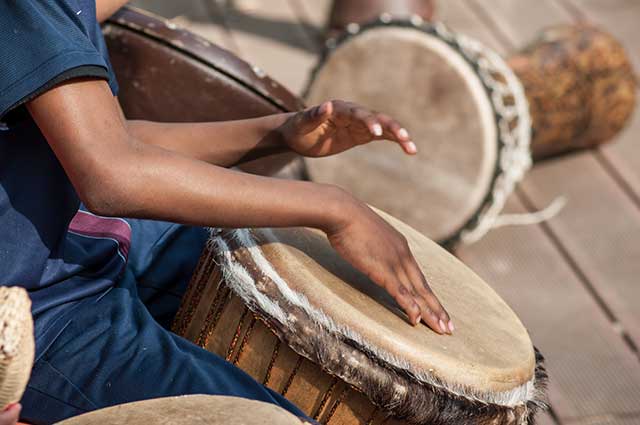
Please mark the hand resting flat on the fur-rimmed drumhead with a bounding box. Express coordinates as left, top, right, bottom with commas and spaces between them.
325, 195, 455, 334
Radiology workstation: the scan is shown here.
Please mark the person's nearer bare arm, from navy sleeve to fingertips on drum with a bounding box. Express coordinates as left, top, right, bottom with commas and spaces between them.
27, 80, 450, 333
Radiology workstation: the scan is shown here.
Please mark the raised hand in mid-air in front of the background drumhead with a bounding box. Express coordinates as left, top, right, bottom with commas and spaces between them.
279, 100, 417, 157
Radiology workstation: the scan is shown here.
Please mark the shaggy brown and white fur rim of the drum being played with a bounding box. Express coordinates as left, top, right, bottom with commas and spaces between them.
208, 229, 547, 425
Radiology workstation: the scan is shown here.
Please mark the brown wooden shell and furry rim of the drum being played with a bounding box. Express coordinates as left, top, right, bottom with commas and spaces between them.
173, 229, 546, 425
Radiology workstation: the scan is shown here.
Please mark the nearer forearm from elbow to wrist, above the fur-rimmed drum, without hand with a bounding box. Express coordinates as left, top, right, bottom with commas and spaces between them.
88, 137, 351, 230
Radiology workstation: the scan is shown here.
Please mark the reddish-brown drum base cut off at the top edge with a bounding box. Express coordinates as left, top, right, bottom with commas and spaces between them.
327, 0, 435, 35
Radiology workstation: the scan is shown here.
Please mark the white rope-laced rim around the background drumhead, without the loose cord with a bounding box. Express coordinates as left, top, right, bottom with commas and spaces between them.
302, 19, 532, 250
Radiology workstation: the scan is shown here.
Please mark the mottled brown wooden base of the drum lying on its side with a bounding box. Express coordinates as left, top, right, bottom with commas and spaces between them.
509, 24, 637, 159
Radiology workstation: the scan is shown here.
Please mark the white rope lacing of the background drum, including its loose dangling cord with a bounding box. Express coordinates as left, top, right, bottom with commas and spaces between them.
316, 17, 566, 246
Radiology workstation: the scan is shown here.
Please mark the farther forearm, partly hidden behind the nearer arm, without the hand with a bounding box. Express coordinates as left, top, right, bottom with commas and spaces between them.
127, 114, 290, 167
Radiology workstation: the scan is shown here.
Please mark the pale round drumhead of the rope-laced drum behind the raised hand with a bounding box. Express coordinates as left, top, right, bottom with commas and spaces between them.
307, 27, 498, 241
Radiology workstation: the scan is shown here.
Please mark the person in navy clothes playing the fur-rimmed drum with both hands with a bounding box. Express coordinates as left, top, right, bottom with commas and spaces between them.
0, 0, 454, 424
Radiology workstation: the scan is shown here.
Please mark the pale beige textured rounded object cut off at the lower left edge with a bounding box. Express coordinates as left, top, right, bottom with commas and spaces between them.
0, 286, 35, 412
